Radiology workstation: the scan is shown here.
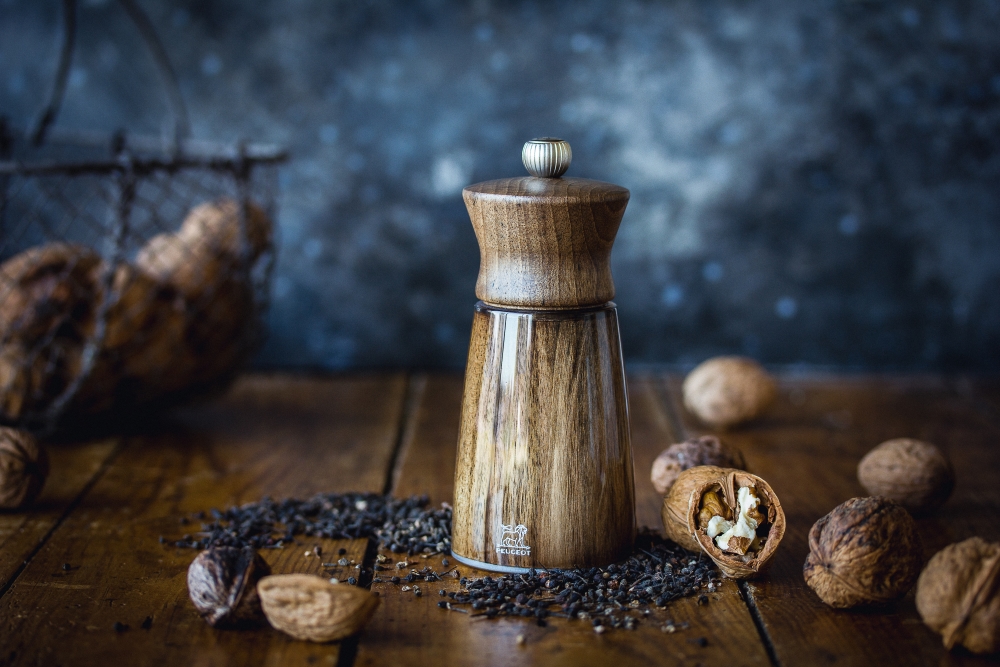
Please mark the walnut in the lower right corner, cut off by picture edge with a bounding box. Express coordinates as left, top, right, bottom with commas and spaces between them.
916, 537, 1000, 653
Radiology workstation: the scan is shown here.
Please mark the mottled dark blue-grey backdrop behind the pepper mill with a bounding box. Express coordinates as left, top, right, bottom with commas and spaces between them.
0, 0, 1000, 370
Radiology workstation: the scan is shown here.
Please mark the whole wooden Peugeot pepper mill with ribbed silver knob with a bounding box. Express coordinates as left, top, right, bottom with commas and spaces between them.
452, 138, 635, 572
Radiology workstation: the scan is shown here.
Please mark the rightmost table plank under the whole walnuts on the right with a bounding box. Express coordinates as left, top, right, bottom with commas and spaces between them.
666, 376, 1000, 665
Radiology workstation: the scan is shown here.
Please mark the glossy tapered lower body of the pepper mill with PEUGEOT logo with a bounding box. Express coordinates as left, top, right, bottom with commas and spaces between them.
452, 305, 635, 568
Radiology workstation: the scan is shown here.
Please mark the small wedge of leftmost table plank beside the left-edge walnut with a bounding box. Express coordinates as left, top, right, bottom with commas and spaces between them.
0, 439, 118, 591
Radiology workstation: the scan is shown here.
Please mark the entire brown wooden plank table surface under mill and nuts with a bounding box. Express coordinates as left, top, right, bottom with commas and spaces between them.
0, 373, 1000, 667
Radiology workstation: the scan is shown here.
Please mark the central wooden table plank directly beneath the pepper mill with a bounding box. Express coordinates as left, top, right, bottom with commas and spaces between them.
356, 377, 769, 666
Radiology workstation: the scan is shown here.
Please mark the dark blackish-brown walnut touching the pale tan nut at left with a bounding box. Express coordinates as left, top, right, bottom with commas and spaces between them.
188, 547, 271, 628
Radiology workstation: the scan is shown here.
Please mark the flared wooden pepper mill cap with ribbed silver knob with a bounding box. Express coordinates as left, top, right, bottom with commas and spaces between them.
462, 138, 629, 310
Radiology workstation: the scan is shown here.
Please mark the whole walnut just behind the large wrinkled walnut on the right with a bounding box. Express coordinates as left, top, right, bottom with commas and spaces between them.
858, 438, 955, 514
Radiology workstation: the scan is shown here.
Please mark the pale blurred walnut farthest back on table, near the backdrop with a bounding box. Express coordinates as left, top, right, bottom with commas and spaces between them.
683, 357, 777, 428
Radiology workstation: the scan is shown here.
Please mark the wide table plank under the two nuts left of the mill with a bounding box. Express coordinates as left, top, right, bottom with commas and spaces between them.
0, 376, 405, 665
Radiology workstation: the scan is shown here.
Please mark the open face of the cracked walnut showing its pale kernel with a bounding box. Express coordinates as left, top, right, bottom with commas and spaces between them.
687, 468, 785, 579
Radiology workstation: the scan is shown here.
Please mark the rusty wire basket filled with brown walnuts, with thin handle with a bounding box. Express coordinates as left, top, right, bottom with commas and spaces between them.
0, 0, 286, 432
